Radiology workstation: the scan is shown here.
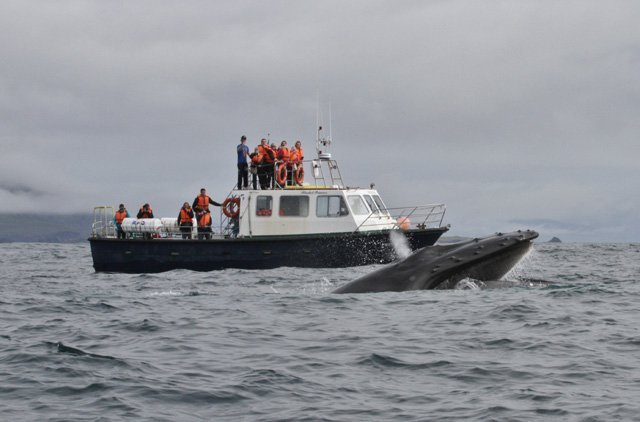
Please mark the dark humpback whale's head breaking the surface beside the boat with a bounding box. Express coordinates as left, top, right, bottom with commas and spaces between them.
333, 230, 538, 293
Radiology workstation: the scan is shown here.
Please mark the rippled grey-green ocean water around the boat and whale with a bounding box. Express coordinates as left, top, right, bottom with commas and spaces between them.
0, 243, 640, 421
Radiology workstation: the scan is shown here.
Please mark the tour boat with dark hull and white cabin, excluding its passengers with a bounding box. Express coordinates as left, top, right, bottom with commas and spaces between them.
89, 126, 449, 273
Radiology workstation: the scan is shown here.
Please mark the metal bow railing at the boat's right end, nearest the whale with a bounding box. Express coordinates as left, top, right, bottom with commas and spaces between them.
356, 204, 446, 231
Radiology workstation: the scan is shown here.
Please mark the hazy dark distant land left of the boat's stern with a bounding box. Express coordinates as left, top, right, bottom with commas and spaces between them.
0, 213, 93, 243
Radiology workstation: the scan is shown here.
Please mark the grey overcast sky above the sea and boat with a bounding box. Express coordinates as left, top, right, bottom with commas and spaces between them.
0, 0, 640, 241
